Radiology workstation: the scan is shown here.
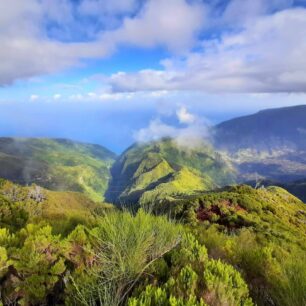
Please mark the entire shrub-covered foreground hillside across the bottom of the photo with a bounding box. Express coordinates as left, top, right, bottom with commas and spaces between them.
0, 180, 306, 306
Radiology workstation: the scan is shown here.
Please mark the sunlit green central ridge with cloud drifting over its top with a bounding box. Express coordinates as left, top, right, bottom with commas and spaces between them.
106, 139, 235, 204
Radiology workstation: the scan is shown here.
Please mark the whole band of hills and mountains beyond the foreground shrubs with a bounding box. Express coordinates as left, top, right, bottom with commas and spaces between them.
0, 105, 306, 204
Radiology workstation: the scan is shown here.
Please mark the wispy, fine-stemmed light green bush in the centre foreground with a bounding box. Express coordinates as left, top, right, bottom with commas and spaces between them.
70, 210, 180, 305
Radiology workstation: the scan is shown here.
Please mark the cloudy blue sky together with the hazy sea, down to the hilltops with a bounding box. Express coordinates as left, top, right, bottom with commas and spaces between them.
0, 0, 306, 153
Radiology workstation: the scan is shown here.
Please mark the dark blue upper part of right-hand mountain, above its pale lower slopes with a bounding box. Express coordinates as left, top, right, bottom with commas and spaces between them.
214, 105, 306, 152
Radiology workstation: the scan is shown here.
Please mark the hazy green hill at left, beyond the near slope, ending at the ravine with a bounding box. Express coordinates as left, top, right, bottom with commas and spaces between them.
0, 138, 115, 201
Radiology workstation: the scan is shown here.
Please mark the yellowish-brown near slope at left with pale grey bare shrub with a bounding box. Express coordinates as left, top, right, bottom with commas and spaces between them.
0, 179, 112, 233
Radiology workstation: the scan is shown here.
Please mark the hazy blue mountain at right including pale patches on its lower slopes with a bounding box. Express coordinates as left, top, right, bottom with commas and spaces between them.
213, 105, 306, 184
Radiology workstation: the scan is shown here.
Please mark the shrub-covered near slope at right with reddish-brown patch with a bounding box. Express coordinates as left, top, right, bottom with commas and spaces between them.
155, 185, 306, 306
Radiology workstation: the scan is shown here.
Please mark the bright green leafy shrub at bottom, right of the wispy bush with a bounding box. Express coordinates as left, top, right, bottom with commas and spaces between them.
128, 234, 253, 306
